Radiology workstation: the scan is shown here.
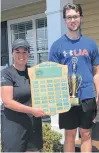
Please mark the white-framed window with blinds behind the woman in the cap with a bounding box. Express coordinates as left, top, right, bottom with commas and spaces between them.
8, 14, 48, 66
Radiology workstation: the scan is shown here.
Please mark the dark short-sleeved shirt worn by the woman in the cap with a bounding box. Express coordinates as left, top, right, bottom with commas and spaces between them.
1, 66, 31, 106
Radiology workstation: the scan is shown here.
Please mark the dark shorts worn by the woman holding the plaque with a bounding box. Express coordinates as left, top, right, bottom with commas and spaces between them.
1, 109, 43, 152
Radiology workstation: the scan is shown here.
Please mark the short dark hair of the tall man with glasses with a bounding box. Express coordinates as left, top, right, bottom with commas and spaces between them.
63, 3, 83, 19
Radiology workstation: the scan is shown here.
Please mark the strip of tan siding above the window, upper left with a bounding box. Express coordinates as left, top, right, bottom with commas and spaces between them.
1, 0, 46, 21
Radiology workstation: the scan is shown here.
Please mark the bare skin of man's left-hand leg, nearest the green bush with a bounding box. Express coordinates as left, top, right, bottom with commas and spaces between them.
64, 129, 77, 152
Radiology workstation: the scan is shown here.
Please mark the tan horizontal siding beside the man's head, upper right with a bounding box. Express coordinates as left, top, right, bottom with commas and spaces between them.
74, 0, 99, 47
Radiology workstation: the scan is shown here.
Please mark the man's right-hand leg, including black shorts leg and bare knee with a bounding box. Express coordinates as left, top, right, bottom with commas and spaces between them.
79, 98, 96, 152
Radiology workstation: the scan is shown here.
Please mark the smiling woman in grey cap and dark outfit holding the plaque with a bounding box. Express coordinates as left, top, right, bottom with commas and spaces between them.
1, 39, 45, 152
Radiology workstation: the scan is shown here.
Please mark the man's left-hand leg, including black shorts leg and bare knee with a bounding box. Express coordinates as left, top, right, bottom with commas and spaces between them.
59, 106, 80, 152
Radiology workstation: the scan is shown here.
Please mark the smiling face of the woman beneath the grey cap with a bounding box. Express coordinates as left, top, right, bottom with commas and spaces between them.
12, 48, 29, 66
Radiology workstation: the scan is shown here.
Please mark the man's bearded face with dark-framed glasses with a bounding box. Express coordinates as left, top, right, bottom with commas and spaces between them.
65, 9, 82, 31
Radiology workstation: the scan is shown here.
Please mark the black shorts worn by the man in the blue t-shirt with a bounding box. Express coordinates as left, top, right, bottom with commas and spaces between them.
59, 98, 97, 130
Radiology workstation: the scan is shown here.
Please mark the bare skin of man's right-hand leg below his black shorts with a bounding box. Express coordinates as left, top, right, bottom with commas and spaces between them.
80, 128, 92, 152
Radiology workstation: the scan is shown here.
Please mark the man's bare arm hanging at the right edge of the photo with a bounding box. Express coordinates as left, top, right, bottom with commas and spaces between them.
93, 65, 99, 105
